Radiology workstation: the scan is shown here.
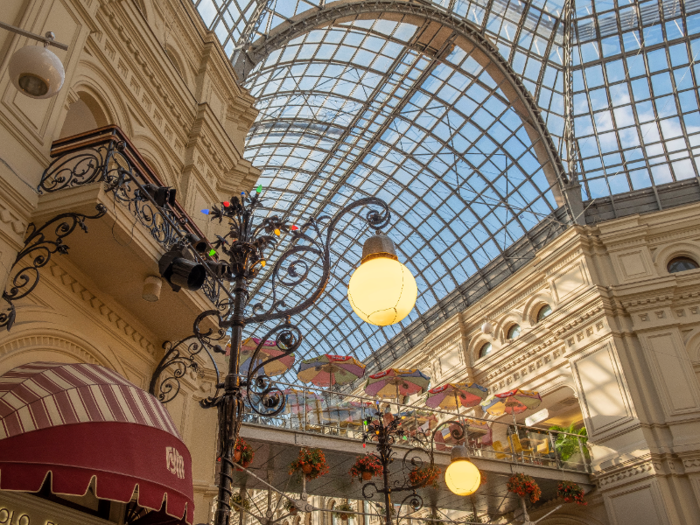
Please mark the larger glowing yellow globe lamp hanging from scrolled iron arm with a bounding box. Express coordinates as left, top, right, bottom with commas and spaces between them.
348, 234, 418, 326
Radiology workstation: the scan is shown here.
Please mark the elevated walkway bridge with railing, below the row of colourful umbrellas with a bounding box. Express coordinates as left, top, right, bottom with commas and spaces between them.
234, 385, 593, 517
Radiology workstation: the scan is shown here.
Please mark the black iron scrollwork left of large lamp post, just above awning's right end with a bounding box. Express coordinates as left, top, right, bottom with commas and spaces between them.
148, 310, 226, 404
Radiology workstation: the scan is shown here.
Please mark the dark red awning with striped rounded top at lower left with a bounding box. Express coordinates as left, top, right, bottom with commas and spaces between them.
0, 363, 194, 525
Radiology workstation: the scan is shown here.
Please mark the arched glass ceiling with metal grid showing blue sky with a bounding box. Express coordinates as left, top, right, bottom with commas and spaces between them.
194, 0, 700, 370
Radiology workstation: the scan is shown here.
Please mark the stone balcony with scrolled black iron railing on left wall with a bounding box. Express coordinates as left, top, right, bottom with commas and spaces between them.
33, 126, 220, 341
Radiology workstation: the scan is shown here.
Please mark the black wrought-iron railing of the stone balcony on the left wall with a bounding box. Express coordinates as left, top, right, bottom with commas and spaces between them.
37, 126, 220, 304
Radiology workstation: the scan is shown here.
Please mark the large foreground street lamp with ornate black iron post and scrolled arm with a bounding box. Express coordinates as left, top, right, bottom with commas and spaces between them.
151, 187, 416, 525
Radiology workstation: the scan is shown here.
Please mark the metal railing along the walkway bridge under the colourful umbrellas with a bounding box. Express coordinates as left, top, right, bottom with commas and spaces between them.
244, 381, 591, 473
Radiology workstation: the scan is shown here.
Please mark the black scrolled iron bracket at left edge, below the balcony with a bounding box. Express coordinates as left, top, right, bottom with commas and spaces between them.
0, 204, 107, 331
